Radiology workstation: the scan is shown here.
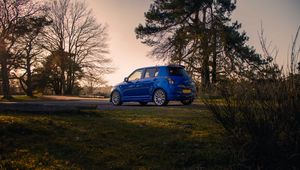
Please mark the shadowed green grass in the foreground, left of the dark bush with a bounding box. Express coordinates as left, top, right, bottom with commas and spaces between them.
0, 106, 229, 169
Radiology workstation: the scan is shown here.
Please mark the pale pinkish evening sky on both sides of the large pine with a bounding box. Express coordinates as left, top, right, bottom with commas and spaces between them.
85, 0, 300, 85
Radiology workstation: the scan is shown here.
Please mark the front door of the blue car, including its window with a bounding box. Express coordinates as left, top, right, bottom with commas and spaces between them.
122, 69, 144, 100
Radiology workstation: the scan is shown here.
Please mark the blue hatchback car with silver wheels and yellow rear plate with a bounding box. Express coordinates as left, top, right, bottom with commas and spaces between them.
110, 65, 196, 106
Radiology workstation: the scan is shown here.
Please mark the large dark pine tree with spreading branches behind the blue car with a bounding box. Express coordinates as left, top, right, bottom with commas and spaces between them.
135, 0, 265, 88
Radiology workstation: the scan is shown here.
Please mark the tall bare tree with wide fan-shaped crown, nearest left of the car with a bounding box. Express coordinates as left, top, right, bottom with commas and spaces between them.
45, 0, 111, 94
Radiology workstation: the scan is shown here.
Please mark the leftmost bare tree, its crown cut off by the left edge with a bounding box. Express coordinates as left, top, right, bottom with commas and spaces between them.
0, 0, 40, 99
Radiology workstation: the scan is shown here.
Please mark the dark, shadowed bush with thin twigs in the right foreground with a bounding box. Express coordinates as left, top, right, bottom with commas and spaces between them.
205, 75, 300, 169
